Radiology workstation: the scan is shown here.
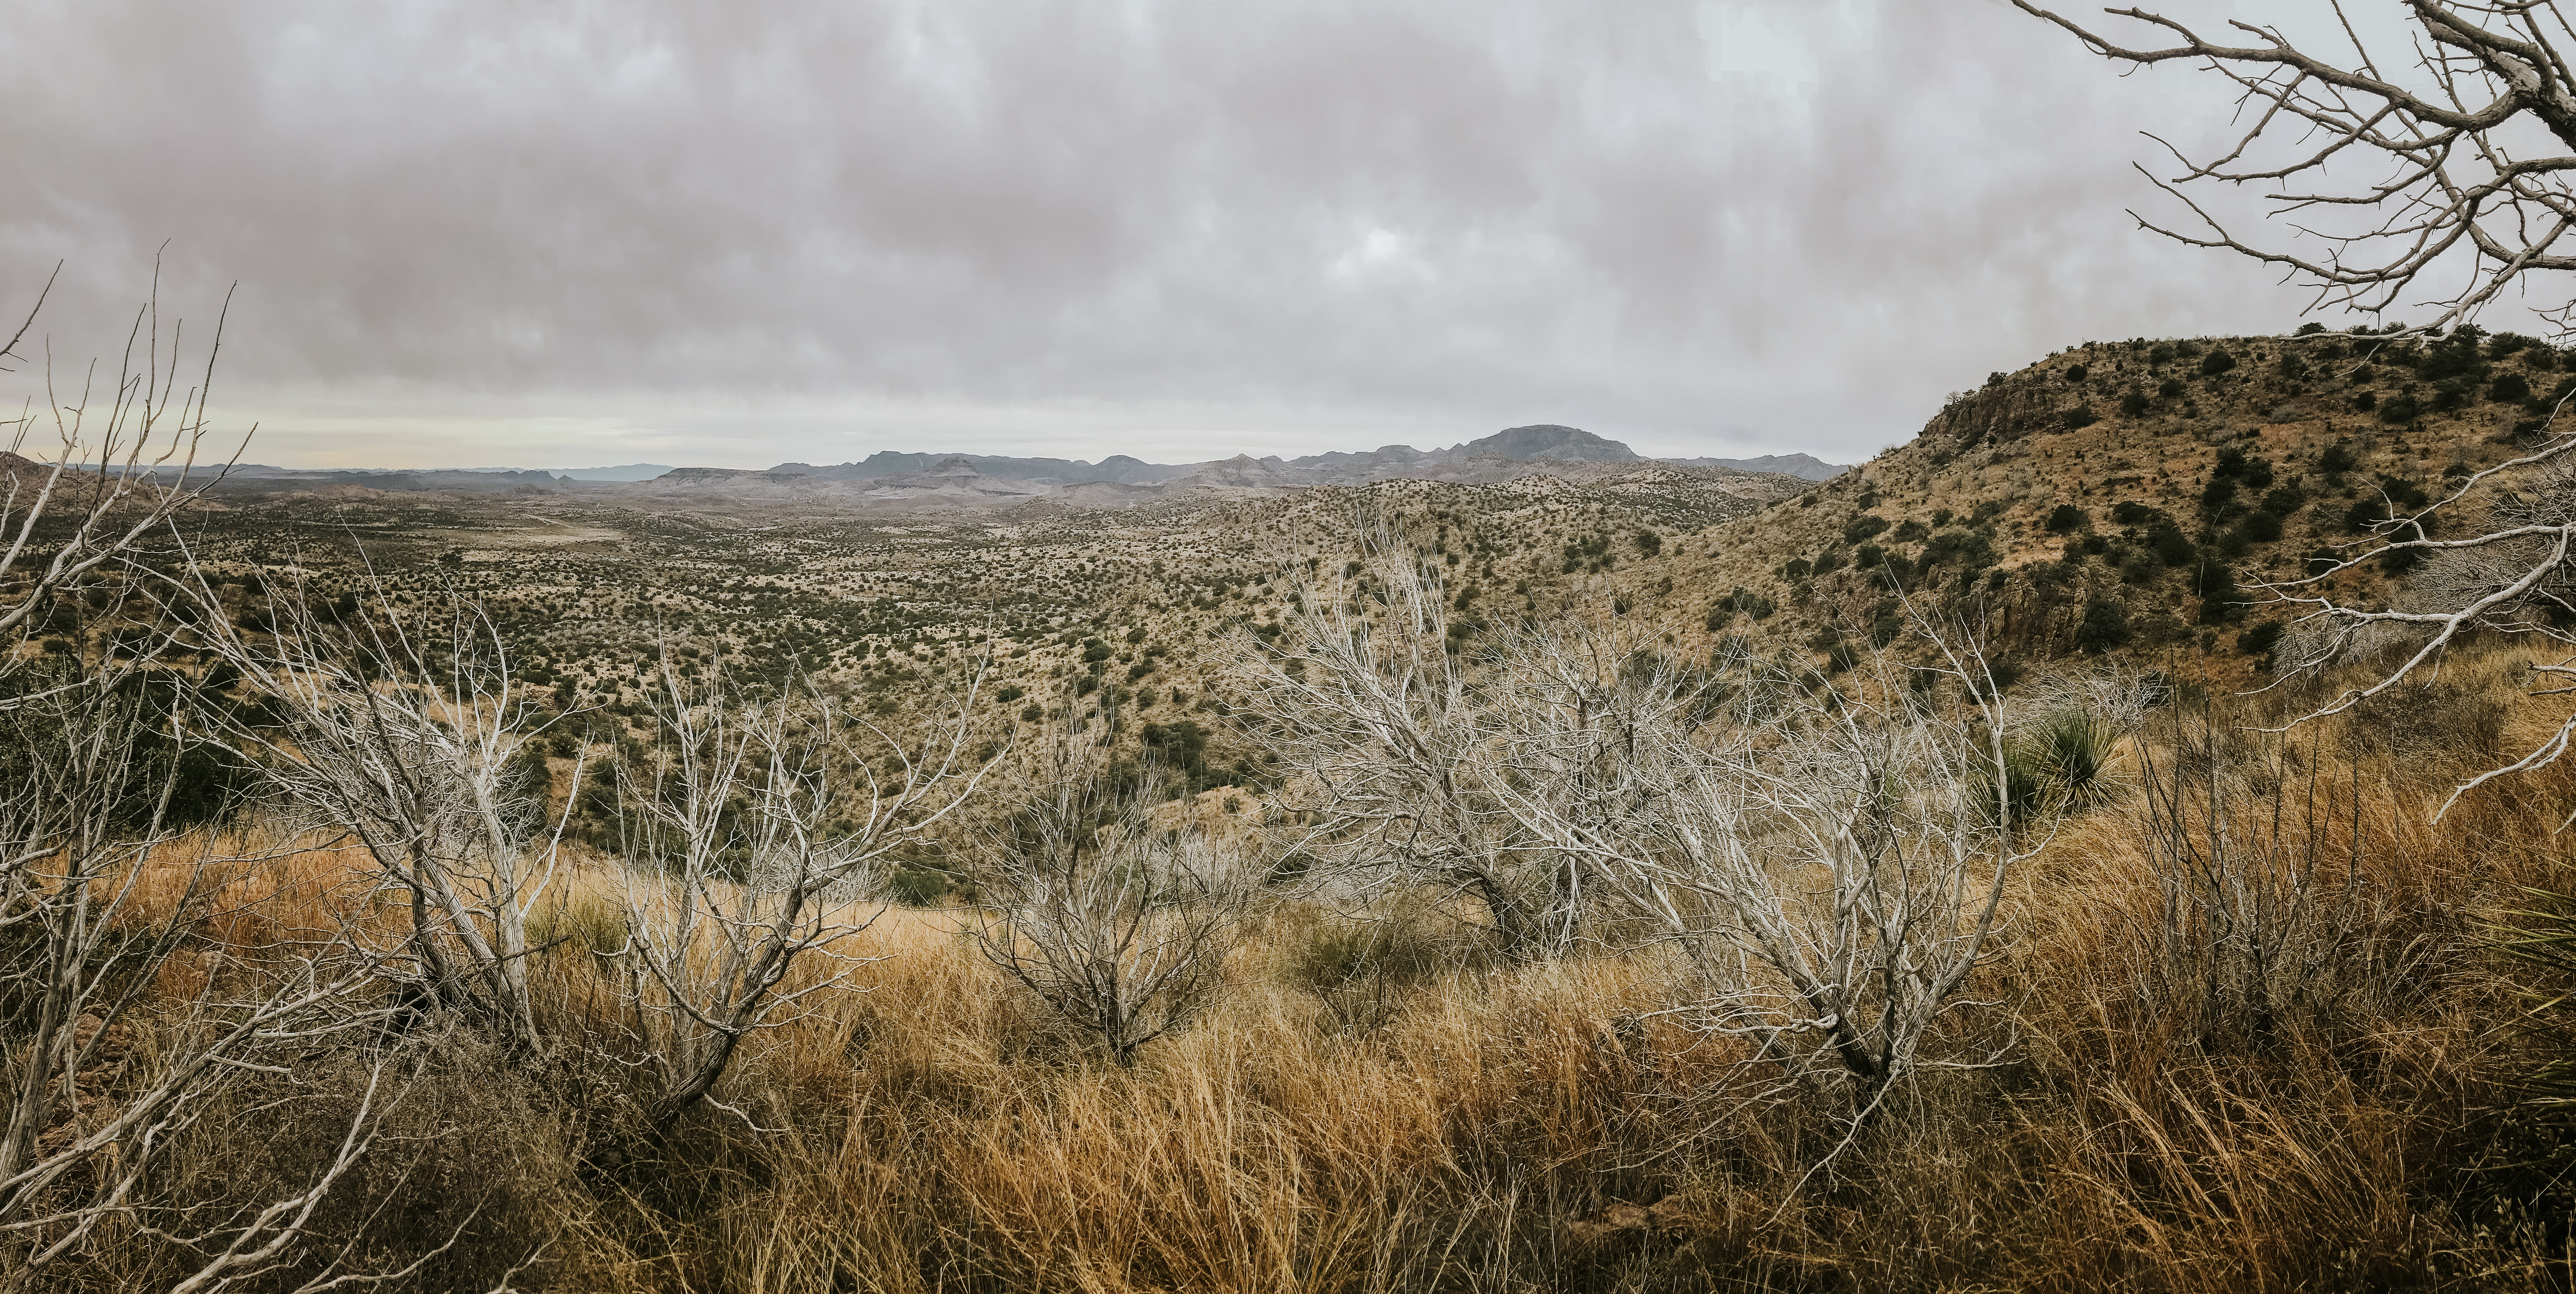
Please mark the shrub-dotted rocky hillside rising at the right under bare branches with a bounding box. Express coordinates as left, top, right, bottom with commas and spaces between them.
1636, 330, 2576, 675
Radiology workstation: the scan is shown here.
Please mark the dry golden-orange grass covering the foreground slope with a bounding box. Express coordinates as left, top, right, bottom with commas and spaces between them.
35, 650, 2576, 1291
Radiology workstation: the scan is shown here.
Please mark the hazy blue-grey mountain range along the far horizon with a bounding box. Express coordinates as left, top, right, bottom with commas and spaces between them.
171, 423, 1842, 505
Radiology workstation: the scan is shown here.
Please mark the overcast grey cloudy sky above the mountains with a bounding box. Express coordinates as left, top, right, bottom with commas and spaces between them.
0, 0, 2535, 466
